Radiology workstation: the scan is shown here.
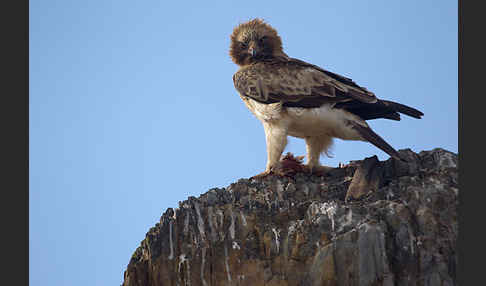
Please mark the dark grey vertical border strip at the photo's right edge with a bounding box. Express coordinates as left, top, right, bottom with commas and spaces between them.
457, 0, 486, 285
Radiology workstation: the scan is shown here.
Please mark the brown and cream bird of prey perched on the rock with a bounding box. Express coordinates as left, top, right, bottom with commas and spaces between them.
229, 18, 423, 176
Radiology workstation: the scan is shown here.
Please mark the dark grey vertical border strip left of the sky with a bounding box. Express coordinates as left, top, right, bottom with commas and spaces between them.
0, 0, 29, 285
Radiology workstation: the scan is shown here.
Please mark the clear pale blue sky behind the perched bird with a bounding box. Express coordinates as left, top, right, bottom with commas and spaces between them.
29, 0, 458, 286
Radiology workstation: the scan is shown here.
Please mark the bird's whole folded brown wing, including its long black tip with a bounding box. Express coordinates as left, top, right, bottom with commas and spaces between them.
233, 58, 423, 120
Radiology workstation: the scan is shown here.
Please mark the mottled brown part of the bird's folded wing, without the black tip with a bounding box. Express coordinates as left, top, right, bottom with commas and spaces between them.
233, 59, 376, 107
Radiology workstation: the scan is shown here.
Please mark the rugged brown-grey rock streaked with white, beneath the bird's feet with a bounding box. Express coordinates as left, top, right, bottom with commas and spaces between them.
123, 149, 459, 286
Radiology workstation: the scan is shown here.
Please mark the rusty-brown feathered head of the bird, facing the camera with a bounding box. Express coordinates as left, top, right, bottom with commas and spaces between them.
230, 18, 286, 66
